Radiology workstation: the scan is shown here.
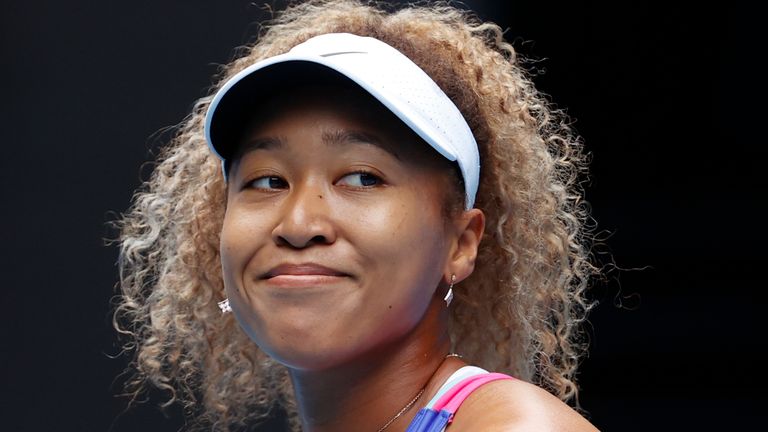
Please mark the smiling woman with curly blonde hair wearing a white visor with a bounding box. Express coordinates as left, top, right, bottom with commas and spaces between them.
116, 0, 594, 432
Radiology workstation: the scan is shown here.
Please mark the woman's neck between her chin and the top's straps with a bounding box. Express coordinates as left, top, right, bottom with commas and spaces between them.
284, 304, 463, 432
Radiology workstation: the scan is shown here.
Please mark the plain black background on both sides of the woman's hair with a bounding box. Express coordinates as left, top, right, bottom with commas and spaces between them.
0, 0, 768, 431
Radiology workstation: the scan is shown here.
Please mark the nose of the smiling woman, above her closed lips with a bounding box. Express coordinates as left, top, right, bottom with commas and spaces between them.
272, 184, 336, 249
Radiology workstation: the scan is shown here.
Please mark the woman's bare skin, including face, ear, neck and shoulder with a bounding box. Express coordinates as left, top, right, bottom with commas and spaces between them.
221, 82, 592, 431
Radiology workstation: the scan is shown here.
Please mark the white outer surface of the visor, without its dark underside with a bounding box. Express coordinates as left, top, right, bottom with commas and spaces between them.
205, 33, 480, 209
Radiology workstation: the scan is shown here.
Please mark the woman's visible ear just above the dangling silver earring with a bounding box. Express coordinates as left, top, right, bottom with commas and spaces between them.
444, 208, 485, 282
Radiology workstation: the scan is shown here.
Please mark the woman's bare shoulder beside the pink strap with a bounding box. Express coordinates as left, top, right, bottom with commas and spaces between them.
448, 379, 597, 432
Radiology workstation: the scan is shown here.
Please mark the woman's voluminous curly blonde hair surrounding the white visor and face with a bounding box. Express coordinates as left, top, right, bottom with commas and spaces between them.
115, 0, 597, 430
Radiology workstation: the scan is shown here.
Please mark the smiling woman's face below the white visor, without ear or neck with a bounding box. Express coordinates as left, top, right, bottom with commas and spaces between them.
221, 85, 462, 369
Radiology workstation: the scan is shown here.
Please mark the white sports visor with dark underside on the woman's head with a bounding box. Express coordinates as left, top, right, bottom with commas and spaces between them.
205, 33, 480, 209
